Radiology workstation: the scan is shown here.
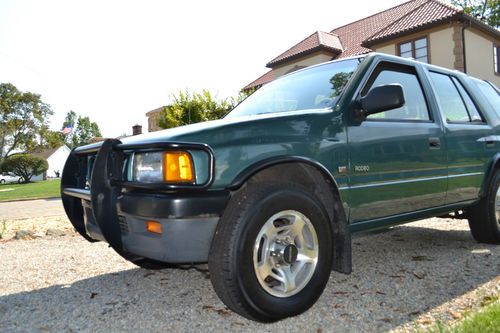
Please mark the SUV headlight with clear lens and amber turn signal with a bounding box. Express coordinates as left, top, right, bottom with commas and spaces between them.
133, 151, 195, 183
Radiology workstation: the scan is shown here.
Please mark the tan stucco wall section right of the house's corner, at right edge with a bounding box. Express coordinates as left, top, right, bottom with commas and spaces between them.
465, 28, 500, 86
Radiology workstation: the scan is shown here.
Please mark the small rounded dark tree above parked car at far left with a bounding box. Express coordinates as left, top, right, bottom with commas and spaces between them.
2, 154, 49, 183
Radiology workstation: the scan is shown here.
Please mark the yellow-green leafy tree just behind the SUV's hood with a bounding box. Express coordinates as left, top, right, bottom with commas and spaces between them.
159, 90, 252, 128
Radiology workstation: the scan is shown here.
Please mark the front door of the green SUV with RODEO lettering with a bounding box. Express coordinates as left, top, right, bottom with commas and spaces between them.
347, 62, 447, 223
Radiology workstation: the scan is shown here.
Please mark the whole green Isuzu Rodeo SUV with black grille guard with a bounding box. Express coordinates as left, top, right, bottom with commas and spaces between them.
61, 53, 500, 322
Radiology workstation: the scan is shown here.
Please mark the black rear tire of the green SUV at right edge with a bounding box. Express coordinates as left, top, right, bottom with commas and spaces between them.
469, 170, 500, 244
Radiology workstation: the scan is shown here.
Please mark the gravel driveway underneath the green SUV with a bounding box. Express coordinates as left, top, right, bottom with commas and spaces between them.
0, 219, 500, 332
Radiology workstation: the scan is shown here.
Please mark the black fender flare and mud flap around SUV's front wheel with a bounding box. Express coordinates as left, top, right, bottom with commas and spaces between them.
227, 156, 352, 274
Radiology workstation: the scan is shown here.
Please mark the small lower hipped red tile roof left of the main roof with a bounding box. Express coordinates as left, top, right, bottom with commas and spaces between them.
266, 31, 342, 67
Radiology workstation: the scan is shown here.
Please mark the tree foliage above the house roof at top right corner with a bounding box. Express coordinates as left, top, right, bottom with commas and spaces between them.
451, 0, 500, 28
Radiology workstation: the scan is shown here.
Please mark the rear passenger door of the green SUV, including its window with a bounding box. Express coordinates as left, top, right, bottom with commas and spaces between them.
429, 70, 498, 204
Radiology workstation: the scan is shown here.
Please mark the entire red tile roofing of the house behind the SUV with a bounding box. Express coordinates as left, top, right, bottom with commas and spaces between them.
244, 0, 500, 89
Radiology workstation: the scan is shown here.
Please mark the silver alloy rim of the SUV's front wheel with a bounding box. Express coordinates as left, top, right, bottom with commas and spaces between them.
253, 210, 319, 297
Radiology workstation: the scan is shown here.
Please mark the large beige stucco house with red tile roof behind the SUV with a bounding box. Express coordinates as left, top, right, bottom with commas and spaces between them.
243, 0, 500, 89
